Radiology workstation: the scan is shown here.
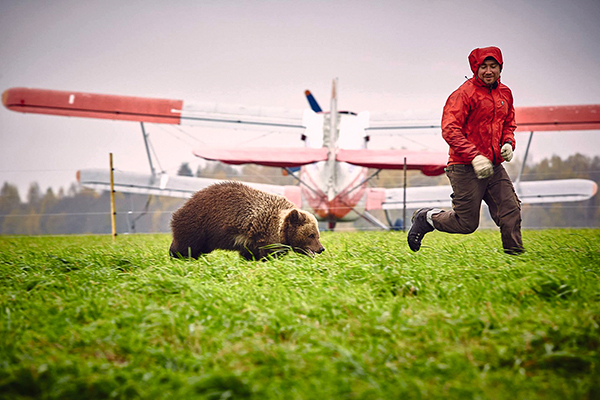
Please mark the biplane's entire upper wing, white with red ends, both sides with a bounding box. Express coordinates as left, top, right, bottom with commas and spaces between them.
7, 88, 600, 131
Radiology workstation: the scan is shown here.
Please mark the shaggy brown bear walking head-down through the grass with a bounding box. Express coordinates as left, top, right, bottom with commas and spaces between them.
169, 181, 325, 260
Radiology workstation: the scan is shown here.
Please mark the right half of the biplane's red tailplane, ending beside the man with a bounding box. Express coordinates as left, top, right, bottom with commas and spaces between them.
336, 149, 448, 176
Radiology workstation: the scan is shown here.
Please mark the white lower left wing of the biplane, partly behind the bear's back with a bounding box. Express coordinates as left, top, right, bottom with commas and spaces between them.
77, 169, 301, 207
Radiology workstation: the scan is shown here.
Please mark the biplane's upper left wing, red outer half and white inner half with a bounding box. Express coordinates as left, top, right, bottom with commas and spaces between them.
2, 88, 304, 128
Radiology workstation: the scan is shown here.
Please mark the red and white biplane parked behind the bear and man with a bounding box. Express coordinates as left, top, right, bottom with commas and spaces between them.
2, 80, 600, 229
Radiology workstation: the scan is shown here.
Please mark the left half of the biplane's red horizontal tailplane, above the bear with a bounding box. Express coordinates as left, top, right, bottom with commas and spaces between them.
194, 147, 327, 168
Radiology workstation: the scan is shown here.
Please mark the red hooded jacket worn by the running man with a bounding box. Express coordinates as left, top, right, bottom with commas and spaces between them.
442, 47, 517, 165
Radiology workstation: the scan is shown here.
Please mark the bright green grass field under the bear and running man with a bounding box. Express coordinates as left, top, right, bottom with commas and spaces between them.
0, 230, 600, 400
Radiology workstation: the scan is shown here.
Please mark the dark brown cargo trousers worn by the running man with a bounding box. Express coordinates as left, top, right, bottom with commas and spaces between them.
432, 164, 523, 254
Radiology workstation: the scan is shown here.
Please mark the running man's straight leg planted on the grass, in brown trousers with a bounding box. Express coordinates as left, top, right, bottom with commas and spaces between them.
483, 165, 525, 254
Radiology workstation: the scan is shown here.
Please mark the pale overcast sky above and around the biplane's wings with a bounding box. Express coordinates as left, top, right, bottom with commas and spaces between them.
0, 0, 600, 199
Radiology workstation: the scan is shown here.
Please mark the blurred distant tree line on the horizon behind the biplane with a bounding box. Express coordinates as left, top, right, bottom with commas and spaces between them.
0, 154, 600, 235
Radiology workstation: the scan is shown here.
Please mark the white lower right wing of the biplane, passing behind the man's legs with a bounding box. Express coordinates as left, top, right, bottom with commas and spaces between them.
367, 179, 598, 210
